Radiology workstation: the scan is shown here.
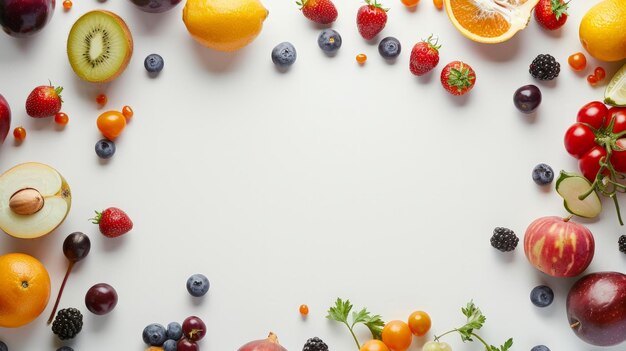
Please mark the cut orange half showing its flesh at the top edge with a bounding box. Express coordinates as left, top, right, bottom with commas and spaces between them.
445, 0, 539, 44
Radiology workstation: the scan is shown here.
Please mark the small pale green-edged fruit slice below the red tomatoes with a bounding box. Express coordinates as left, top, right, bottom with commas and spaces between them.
556, 171, 602, 218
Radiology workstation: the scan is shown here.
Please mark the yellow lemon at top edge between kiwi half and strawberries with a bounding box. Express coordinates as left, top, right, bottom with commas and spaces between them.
183, 0, 269, 51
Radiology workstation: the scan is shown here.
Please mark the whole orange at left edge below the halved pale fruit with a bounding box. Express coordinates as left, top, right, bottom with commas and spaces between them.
0, 253, 50, 328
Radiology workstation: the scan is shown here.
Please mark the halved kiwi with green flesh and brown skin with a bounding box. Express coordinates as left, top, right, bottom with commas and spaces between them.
67, 10, 133, 83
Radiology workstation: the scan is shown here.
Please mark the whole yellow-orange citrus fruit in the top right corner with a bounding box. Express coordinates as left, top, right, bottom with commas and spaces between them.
578, 0, 626, 61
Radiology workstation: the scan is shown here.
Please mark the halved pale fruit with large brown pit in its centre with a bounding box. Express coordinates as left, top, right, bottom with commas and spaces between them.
0, 162, 72, 239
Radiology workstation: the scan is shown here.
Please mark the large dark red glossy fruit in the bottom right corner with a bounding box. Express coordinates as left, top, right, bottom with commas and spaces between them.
566, 272, 626, 346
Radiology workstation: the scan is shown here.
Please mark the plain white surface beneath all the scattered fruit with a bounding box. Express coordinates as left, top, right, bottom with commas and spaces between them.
0, 0, 626, 351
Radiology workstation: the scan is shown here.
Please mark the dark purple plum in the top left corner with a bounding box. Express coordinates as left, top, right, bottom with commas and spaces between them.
0, 0, 55, 38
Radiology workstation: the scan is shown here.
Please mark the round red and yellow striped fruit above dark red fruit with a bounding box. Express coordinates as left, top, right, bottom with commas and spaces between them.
524, 216, 595, 277
